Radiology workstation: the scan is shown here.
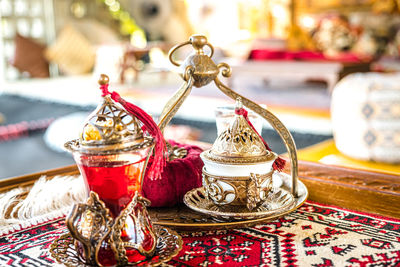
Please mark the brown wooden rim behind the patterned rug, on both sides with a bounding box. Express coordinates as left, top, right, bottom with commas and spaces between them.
0, 161, 400, 218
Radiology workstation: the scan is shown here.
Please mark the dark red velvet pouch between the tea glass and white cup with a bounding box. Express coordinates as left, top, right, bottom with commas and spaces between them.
142, 140, 204, 207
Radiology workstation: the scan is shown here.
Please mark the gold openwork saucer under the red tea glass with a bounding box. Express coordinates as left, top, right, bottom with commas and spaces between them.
50, 226, 182, 267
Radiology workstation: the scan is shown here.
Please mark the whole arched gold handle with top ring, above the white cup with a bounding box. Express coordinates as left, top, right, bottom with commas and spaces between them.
158, 35, 298, 197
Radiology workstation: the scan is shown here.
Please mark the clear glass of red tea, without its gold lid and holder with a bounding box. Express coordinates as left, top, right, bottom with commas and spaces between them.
73, 146, 156, 266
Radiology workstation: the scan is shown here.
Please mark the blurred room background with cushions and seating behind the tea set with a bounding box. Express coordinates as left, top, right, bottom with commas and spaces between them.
0, 0, 400, 178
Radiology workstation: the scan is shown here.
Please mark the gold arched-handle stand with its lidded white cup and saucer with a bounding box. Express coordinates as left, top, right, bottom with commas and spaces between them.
158, 35, 308, 220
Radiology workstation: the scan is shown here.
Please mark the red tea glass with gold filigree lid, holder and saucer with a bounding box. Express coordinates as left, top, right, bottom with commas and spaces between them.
51, 75, 182, 266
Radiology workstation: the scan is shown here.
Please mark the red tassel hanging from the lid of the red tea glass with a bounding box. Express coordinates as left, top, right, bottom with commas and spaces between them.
100, 84, 167, 180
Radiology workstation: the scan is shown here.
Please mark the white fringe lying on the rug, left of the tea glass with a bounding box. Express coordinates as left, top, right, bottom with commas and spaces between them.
0, 176, 87, 235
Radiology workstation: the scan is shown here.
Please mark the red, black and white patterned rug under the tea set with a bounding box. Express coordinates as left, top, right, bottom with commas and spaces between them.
0, 202, 400, 267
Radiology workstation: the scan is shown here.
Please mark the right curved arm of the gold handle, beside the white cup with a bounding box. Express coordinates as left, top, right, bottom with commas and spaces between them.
214, 78, 298, 197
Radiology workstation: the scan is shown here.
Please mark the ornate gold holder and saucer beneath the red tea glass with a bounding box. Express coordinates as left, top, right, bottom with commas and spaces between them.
50, 194, 182, 266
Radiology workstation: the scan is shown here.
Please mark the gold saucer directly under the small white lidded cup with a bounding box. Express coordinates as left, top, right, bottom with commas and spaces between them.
183, 187, 295, 221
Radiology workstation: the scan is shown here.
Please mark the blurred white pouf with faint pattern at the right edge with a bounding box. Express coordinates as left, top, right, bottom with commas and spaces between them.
331, 73, 400, 163
